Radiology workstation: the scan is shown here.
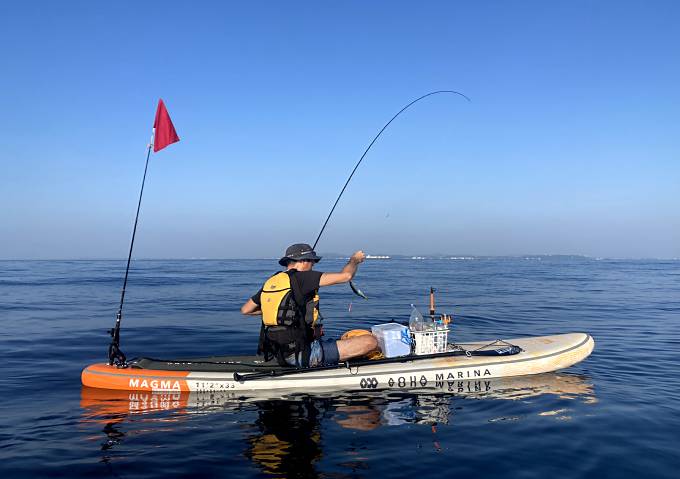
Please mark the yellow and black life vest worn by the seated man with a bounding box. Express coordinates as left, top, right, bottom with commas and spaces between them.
258, 269, 319, 366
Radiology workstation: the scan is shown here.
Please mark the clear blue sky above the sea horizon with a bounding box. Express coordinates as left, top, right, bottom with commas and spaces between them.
0, 1, 680, 259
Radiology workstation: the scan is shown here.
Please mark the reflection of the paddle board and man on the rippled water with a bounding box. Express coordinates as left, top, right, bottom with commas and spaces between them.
81, 373, 597, 477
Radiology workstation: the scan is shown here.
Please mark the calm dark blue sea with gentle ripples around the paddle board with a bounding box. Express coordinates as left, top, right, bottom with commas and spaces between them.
0, 257, 680, 479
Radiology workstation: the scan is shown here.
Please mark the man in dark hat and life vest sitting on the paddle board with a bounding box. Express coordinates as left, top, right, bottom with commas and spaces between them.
241, 244, 378, 367
